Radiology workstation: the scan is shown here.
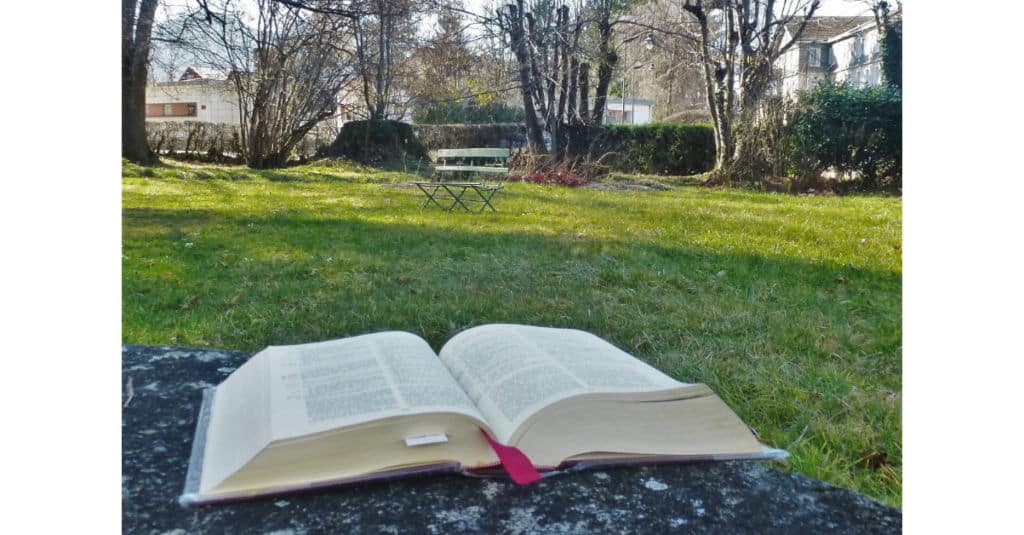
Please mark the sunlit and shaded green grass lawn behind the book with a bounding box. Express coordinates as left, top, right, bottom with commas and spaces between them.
122, 156, 902, 506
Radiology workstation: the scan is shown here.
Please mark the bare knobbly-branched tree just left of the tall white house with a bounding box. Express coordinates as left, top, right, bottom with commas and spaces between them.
683, 0, 820, 180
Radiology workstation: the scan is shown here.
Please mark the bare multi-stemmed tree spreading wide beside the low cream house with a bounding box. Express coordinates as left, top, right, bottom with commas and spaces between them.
166, 0, 353, 168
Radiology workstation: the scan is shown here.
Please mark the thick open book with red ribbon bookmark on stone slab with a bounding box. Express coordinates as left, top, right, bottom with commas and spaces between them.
180, 325, 777, 504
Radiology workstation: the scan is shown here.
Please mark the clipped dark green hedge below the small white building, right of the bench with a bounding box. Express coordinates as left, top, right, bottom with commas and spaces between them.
589, 123, 715, 174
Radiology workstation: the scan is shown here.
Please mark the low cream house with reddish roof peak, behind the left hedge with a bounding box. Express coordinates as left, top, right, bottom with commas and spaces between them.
145, 67, 240, 124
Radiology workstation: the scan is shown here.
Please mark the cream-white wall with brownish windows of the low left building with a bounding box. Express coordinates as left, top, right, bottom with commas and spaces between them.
145, 80, 239, 124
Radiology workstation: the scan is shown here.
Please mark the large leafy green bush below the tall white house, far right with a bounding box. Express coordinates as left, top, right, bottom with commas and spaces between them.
785, 84, 903, 190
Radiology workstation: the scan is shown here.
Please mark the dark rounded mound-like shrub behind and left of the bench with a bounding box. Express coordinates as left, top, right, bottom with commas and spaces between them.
318, 121, 429, 163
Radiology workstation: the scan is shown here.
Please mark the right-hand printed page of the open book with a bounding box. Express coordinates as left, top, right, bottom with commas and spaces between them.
440, 325, 686, 442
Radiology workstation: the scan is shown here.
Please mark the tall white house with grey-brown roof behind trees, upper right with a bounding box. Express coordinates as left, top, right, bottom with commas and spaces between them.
777, 16, 897, 98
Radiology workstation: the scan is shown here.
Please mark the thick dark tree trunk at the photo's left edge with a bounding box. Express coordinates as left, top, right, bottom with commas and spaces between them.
121, 0, 158, 164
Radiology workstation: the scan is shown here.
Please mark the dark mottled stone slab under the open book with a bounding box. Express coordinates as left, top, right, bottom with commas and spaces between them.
122, 345, 902, 534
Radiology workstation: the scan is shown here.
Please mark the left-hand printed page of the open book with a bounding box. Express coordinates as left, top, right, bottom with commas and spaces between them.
270, 332, 483, 439
